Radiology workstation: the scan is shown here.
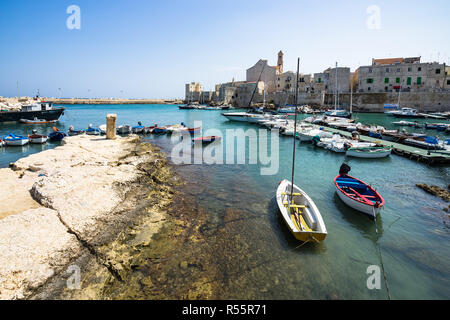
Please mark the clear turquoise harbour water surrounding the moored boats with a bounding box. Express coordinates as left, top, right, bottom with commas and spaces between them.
0, 105, 450, 299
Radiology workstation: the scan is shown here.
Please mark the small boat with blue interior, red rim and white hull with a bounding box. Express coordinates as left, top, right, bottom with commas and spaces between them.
334, 175, 384, 218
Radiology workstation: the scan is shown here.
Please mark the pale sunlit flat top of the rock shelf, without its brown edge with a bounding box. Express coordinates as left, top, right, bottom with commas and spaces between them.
0, 135, 152, 299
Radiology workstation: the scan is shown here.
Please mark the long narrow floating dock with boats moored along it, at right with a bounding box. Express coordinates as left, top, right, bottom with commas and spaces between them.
321, 126, 450, 165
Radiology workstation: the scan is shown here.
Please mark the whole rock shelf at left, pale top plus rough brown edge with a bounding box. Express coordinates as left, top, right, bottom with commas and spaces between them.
0, 135, 176, 299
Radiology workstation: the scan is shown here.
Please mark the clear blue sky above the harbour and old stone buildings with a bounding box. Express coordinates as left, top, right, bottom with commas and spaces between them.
0, 0, 450, 99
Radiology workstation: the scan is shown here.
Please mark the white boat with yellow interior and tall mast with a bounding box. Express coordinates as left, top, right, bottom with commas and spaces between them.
276, 180, 327, 242
